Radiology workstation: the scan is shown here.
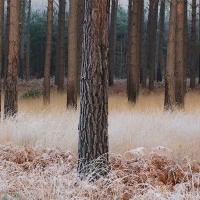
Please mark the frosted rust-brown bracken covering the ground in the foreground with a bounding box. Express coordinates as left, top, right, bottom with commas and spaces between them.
0, 144, 200, 200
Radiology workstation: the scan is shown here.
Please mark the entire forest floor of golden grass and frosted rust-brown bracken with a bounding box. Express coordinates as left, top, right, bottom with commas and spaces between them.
0, 80, 200, 200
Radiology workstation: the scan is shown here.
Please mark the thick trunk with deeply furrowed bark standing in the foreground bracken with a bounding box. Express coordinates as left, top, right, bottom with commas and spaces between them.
78, 0, 110, 180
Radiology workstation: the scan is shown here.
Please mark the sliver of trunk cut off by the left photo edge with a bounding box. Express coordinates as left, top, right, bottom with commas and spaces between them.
0, 0, 4, 119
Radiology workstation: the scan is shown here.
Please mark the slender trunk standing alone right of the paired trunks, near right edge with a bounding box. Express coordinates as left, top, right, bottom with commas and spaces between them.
190, 0, 196, 89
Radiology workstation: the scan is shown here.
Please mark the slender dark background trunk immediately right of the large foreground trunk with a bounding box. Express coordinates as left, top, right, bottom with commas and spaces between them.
108, 0, 118, 86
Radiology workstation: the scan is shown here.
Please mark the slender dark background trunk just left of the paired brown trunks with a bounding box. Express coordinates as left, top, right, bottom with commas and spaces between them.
157, 0, 165, 82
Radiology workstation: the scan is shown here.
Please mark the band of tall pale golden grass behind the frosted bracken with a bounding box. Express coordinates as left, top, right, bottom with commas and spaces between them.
0, 94, 200, 159
